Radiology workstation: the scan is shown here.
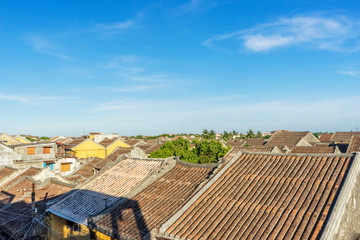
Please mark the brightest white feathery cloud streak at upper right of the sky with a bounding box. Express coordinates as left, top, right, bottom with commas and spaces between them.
203, 15, 360, 52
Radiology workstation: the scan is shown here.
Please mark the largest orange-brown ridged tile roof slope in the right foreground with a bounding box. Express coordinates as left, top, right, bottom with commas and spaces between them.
165, 153, 353, 239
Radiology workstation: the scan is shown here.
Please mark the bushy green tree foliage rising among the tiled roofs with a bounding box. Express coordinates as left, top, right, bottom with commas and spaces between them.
150, 138, 230, 163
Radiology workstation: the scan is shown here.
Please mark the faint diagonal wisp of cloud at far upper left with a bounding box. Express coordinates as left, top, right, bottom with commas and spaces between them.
25, 35, 70, 59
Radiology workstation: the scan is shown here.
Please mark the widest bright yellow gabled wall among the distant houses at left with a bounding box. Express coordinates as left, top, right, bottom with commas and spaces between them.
71, 141, 105, 158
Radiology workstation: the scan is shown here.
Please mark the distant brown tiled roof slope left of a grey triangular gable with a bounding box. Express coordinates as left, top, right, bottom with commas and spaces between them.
265, 132, 309, 148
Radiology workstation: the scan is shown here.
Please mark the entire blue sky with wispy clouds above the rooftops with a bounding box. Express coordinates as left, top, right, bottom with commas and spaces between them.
0, 0, 360, 136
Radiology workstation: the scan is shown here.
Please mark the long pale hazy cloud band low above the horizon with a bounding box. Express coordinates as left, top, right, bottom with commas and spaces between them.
89, 96, 360, 132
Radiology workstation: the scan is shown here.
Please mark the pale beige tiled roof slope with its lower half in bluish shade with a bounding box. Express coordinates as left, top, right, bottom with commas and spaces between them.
50, 159, 163, 224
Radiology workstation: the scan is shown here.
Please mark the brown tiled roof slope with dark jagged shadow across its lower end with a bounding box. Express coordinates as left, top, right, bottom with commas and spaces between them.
95, 163, 216, 239
